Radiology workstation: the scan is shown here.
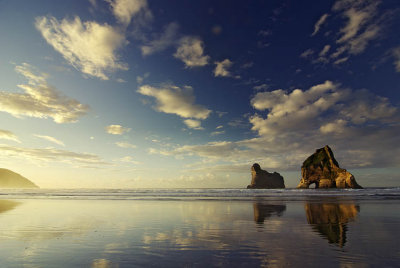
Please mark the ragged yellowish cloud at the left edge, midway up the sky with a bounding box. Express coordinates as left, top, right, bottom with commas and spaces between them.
0, 63, 89, 123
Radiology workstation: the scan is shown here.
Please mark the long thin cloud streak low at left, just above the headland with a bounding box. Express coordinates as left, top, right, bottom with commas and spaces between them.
0, 144, 107, 165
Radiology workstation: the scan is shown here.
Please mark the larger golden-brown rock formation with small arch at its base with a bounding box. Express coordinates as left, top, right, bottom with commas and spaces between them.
297, 145, 362, 189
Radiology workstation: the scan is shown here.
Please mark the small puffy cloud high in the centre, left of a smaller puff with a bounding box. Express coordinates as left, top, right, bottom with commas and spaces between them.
174, 36, 210, 68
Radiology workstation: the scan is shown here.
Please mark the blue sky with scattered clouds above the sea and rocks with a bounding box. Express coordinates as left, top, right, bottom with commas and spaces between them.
0, 0, 400, 188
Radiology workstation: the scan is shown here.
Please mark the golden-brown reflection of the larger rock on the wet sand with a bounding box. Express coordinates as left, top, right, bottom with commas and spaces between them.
305, 203, 360, 247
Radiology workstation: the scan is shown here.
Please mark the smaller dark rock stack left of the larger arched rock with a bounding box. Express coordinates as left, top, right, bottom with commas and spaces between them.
247, 163, 285, 189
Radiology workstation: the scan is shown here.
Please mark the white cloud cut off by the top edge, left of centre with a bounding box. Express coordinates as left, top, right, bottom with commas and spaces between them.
106, 0, 153, 26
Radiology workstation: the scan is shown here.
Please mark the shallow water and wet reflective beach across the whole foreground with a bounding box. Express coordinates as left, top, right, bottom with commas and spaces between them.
0, 188, 400, 267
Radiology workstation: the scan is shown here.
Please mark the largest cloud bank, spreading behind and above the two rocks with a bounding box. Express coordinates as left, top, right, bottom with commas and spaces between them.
152, 81, 400, 170
